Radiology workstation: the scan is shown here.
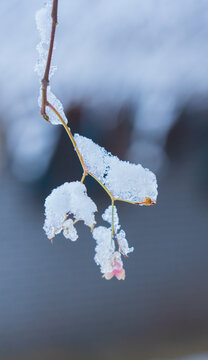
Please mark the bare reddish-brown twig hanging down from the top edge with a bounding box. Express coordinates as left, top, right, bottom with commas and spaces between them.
40, 0, 58, 121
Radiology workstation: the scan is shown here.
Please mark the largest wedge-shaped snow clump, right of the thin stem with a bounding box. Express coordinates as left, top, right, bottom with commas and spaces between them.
75, 134, 158, 205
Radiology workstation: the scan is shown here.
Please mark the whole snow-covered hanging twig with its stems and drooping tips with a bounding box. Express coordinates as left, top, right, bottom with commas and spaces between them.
36, 0, 157, 280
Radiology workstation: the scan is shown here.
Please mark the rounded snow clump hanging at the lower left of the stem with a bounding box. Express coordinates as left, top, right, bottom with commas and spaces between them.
43, 181, 97, 241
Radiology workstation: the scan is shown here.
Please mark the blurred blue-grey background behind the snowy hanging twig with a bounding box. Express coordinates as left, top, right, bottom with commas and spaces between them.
0, 0, 208, 360
